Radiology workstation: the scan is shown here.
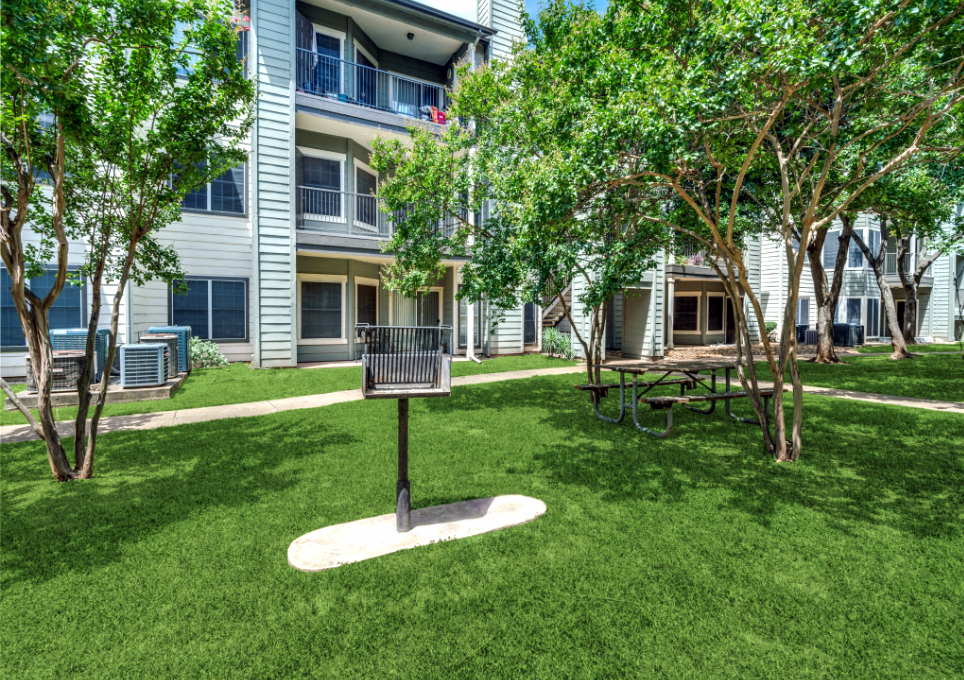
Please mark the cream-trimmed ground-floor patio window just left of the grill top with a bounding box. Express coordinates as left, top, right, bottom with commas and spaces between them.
298, 274, 348, 345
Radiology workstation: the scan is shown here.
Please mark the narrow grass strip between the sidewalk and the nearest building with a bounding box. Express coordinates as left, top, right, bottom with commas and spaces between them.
0, 354, 575, 425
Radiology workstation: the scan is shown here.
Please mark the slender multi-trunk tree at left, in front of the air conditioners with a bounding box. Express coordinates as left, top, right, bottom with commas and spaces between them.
4, 0, 253, 480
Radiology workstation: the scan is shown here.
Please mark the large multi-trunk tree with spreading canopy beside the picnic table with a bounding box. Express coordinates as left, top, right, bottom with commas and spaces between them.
382, 0, 964, 461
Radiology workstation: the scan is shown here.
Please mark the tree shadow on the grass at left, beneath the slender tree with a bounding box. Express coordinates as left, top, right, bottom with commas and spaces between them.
3, 419, 355, 585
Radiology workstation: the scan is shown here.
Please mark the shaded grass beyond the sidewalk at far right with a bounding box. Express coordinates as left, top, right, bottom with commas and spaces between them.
757, 354, 964, 401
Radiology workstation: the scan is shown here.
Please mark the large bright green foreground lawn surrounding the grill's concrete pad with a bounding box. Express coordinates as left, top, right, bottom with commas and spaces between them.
0, 376, 964, 678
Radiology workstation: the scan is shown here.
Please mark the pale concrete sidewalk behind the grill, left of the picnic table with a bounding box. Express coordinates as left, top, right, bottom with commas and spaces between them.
0, 365, 586, 444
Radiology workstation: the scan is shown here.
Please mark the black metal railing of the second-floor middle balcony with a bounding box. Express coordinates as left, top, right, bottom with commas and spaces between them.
298, 186, 468, 238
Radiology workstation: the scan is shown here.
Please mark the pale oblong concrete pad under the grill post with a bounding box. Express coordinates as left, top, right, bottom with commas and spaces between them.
288, 495, 546, 571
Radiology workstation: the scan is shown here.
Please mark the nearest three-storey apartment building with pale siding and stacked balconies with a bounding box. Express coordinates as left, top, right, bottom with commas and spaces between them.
0, 0, 539, 377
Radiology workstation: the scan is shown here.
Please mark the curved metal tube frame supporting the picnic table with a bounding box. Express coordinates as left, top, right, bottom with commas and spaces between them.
592, 362, 760, 439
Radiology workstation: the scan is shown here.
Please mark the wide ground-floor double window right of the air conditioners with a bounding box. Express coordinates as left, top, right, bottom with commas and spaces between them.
171, 278, 248, 342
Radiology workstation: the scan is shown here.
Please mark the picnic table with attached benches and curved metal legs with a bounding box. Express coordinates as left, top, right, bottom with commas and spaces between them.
576, 359, 773, 439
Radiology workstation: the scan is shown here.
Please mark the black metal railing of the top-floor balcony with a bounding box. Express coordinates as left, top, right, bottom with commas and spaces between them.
296, 48, 448, 120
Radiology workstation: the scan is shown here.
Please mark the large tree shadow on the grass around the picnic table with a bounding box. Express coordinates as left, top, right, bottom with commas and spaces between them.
426, 377, 964, 538
